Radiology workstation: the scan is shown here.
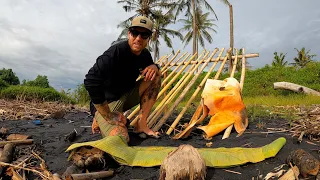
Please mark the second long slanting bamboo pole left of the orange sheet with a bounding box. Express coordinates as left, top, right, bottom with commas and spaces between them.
153, 48, 218, 131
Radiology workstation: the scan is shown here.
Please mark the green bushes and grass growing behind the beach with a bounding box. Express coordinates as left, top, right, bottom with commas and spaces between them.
0, 49, 320, 119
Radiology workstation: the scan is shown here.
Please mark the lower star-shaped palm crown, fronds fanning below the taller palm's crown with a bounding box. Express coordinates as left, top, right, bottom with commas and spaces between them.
179, 8, 216, 53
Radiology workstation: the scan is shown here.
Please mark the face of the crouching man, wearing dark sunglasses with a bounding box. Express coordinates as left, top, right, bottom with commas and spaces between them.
128, 27, 151, 55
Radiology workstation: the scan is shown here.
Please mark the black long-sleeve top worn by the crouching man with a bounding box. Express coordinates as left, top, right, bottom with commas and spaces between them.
84, 41, 154, 104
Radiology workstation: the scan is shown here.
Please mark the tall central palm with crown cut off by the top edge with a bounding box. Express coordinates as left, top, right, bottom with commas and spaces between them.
170, 0, 218, 54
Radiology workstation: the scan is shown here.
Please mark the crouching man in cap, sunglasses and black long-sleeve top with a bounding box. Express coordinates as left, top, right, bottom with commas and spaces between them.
84, 16, 161, 141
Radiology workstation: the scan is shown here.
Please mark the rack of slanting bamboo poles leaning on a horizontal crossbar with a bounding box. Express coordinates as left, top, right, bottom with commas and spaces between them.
127, 48, 259, 138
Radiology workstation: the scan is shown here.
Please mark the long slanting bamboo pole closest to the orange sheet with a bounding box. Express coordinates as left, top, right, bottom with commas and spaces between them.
167, 48, 224, 135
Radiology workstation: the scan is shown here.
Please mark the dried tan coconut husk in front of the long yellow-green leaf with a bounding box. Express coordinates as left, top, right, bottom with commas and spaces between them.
159, 144, 206, 180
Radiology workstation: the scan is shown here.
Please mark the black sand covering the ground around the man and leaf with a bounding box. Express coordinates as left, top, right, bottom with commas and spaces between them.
0, 111, 319, 180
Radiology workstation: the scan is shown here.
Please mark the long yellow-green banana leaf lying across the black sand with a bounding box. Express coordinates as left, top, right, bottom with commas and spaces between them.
66, 136, 286, 168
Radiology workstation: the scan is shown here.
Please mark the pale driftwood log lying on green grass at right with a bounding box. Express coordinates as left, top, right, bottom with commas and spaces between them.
273, 82, 320, 96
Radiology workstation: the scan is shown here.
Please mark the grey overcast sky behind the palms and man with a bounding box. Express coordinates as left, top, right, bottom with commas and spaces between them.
0, 0, 320, 90
